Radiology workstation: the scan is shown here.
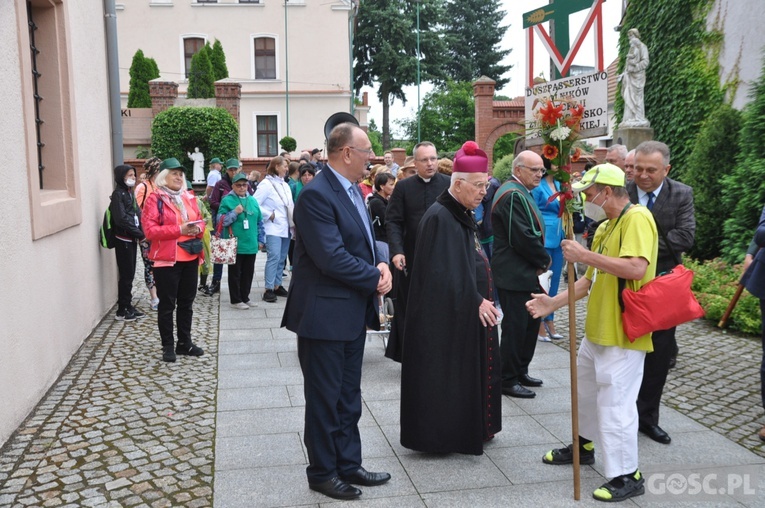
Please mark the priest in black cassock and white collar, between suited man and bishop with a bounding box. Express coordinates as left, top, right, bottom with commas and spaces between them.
385, 141, 449, 362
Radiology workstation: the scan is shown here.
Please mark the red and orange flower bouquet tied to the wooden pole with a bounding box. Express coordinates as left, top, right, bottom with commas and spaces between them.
534, 97, 584, 222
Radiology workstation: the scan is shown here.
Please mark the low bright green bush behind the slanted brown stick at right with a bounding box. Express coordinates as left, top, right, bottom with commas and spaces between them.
684, 258, 762, 335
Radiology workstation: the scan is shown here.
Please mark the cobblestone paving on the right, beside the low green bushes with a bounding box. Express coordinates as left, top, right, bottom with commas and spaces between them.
552, 278, 765, 457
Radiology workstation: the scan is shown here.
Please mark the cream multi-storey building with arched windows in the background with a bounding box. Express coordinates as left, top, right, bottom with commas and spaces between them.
117, 0, 354, 158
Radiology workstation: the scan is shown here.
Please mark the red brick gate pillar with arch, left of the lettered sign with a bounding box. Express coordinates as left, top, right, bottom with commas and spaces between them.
473, 76, 526, 173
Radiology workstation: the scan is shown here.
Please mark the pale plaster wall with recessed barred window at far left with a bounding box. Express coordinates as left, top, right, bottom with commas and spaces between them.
0, 0, 117, 444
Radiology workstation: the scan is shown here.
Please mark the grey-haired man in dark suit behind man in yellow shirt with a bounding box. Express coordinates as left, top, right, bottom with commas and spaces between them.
627, 141, 696, 444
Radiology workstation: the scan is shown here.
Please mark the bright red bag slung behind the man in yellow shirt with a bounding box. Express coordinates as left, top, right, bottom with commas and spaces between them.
619, 265, 704, 342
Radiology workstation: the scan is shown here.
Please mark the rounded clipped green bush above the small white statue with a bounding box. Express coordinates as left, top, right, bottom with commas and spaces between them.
151, 106, 239, 178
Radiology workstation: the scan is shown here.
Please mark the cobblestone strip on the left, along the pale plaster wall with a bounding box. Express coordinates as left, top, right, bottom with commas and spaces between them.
0, 257, 218, 508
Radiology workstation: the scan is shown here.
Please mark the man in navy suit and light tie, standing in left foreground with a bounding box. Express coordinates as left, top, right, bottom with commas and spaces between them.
282, 123, 391, 499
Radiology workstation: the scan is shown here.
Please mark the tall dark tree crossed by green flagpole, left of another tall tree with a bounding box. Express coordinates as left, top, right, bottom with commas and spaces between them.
353, 0, 446, 149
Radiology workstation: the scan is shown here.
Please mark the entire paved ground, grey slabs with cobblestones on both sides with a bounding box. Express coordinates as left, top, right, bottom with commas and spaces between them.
0, 262, 765, 508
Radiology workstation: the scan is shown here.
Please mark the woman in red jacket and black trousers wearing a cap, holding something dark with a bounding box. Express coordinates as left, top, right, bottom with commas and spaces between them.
143, 158, 205, 362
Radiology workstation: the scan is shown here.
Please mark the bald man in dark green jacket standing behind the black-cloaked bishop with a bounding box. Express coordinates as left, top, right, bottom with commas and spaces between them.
491, 150, 551, 399
